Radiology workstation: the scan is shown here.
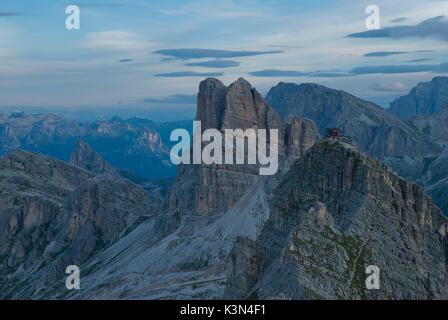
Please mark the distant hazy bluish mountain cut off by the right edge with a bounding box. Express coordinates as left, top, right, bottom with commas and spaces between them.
389, 77, 448, 118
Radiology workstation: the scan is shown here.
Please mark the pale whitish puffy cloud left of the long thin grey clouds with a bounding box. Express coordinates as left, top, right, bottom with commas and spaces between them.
83, 30, 150, 52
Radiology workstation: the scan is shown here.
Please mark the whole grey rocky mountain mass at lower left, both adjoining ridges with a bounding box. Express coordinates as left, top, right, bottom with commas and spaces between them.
0, 149, 150, 298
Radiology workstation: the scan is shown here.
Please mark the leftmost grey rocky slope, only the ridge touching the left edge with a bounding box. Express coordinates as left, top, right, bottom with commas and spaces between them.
0, 150, 93, 275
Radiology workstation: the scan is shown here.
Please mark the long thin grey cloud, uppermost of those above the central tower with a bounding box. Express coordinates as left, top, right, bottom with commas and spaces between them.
153, 48, 283, 60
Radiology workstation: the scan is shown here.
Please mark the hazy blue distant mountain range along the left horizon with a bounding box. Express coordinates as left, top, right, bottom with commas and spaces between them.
0, 113, 192, 179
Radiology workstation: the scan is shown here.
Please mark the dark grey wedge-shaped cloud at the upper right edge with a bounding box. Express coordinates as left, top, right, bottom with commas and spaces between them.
347, 16, 448, 41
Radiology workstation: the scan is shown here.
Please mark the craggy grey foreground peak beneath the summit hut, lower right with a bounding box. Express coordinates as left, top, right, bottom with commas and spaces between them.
225, 141, 448, 299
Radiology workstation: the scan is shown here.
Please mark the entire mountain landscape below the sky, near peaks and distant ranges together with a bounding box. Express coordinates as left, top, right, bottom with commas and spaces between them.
0, 78, 448, 299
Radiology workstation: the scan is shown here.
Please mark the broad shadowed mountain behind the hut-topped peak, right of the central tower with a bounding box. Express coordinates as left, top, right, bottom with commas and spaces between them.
266, 83, 442, 178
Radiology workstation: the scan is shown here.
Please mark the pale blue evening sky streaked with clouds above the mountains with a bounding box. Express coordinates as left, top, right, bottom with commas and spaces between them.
0, 0, 448, 120
